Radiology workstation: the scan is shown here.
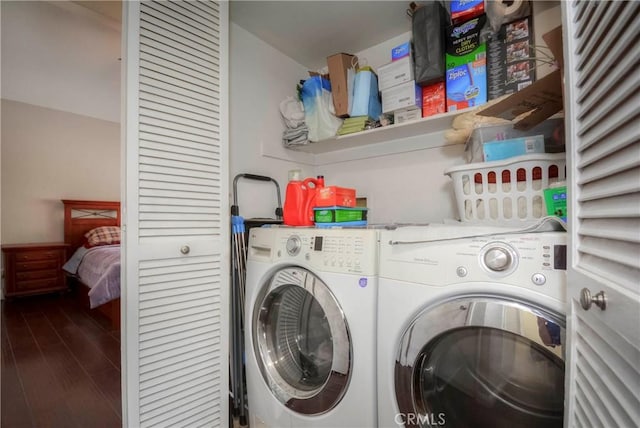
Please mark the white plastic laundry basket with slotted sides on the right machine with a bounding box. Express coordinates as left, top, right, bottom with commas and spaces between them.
445, 153, 566, 225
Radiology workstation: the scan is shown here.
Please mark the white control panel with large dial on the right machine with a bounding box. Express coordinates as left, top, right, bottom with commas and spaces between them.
380, 229, 567, 296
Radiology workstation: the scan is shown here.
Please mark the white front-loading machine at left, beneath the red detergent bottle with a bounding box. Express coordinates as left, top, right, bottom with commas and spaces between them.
245, 227, 378, 428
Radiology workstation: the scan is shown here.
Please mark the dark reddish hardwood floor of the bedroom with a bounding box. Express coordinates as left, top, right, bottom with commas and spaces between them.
0, 295, 121, 428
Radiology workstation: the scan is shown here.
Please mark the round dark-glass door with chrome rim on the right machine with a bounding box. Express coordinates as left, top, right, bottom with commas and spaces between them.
395, 296, 565, 428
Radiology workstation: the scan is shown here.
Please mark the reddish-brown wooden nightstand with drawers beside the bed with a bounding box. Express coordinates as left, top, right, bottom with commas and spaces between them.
2, 242, 69, 297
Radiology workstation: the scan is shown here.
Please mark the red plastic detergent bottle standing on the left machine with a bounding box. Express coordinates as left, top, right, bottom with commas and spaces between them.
282, 171, 324, 226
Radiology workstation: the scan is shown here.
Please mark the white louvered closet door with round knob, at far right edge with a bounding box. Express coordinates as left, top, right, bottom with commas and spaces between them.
563, 1, 640, 428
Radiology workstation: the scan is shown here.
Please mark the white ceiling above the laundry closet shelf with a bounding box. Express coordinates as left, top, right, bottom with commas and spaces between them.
229, 0, 411, 70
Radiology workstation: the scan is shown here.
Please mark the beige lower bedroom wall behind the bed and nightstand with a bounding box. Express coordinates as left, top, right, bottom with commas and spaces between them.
0, 100, 120, 244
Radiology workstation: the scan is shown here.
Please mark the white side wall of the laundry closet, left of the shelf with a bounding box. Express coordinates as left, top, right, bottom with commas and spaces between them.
229, 23, 315, 217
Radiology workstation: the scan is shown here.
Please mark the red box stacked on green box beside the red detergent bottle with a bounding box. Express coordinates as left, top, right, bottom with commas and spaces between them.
313, 186, 367, 227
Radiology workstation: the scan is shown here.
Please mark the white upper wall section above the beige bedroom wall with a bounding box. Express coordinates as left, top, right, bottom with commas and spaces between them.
1, 1, 120, 122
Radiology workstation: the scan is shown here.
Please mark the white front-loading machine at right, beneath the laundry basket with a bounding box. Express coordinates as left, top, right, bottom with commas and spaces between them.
378, 226, 566, 428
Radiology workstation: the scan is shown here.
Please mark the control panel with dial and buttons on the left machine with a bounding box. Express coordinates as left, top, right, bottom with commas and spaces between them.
274, 228, 378, 276
